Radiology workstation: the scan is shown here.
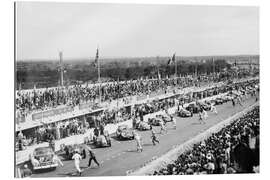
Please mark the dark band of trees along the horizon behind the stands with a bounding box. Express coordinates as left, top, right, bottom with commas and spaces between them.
16, 59, 231, 89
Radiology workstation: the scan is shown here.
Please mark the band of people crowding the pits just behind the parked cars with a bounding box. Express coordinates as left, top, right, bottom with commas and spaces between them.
16, 76, 258, 150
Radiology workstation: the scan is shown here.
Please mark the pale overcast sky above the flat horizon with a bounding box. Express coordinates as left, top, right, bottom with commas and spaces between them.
17, 2, 259, 60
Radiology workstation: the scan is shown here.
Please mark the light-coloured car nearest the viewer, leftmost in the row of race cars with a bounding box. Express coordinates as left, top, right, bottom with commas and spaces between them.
30, 147, 58, 170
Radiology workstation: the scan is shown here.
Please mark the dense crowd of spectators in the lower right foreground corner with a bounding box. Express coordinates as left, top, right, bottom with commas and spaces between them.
154, 106, 260, 175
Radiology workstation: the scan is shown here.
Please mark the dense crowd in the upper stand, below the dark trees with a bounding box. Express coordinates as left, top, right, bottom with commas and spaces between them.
16, 75, 226, 117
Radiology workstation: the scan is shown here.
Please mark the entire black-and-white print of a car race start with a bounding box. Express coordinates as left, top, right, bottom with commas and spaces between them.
14, 1, 261, 178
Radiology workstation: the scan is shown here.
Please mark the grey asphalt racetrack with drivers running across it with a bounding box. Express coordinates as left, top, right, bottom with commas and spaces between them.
31, 95, 255, 177
